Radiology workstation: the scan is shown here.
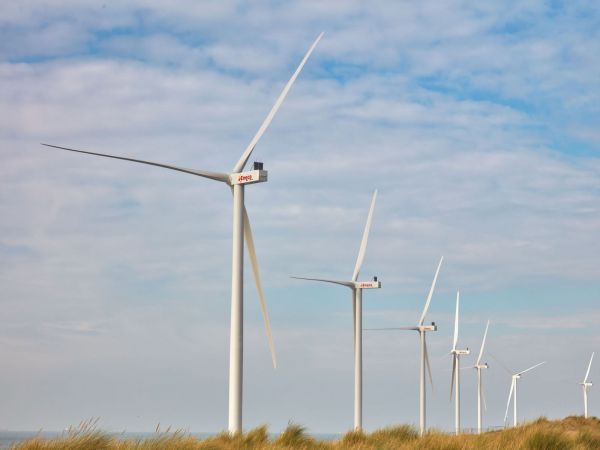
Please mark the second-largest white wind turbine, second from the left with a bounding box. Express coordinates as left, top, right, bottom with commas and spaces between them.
292, 189, 381, 430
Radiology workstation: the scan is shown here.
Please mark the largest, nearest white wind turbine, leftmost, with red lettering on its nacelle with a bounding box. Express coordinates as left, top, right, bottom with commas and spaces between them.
42, 33, 323, 434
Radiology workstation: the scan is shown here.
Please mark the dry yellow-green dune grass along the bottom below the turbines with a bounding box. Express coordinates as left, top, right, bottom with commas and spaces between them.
11, 416, 600, 450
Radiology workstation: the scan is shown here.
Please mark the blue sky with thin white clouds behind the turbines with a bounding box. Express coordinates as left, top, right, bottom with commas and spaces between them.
0, 0, 600, 433
